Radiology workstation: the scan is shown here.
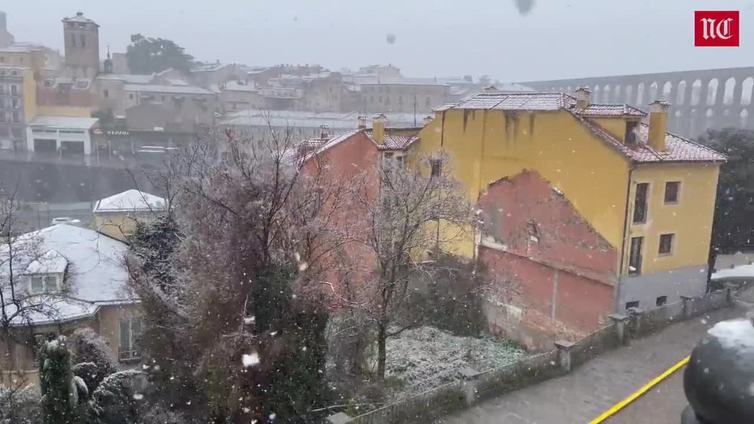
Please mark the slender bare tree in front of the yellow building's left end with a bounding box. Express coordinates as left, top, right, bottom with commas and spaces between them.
342, 157, 472, 379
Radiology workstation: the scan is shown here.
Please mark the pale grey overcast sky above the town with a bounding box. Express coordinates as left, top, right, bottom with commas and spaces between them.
0, 0, 754, 81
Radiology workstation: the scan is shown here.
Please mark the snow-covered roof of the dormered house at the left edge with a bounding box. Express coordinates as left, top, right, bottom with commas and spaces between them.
0, 224, 136, 325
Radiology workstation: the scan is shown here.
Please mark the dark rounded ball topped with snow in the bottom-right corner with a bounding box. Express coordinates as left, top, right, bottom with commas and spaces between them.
681, 319, 754, 424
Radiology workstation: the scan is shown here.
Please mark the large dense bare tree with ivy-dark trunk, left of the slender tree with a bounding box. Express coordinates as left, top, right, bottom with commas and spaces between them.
129, 128, 352, 422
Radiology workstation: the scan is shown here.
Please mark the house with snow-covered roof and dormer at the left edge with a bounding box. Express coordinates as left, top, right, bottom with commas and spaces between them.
0, 224, 141, 383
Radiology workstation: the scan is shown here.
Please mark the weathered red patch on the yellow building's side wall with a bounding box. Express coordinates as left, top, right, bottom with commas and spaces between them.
478, 171, 617, 348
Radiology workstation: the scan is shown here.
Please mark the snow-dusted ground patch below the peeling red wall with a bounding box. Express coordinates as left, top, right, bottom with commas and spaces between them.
386, 327, 525, 393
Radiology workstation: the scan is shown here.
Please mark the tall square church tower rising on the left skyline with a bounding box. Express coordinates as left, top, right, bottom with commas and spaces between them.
63, 12, 99, 78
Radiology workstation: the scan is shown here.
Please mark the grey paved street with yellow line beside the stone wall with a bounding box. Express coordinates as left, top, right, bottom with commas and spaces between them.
439, 307, 746, 424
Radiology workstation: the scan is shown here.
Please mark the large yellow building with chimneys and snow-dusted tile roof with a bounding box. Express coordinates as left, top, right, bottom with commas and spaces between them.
418, 89, 725, 310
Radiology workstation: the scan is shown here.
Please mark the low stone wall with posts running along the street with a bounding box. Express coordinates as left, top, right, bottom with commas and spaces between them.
330, 288, 733, 424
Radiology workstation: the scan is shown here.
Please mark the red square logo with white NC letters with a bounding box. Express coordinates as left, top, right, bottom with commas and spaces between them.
694, 10, 739, 47
